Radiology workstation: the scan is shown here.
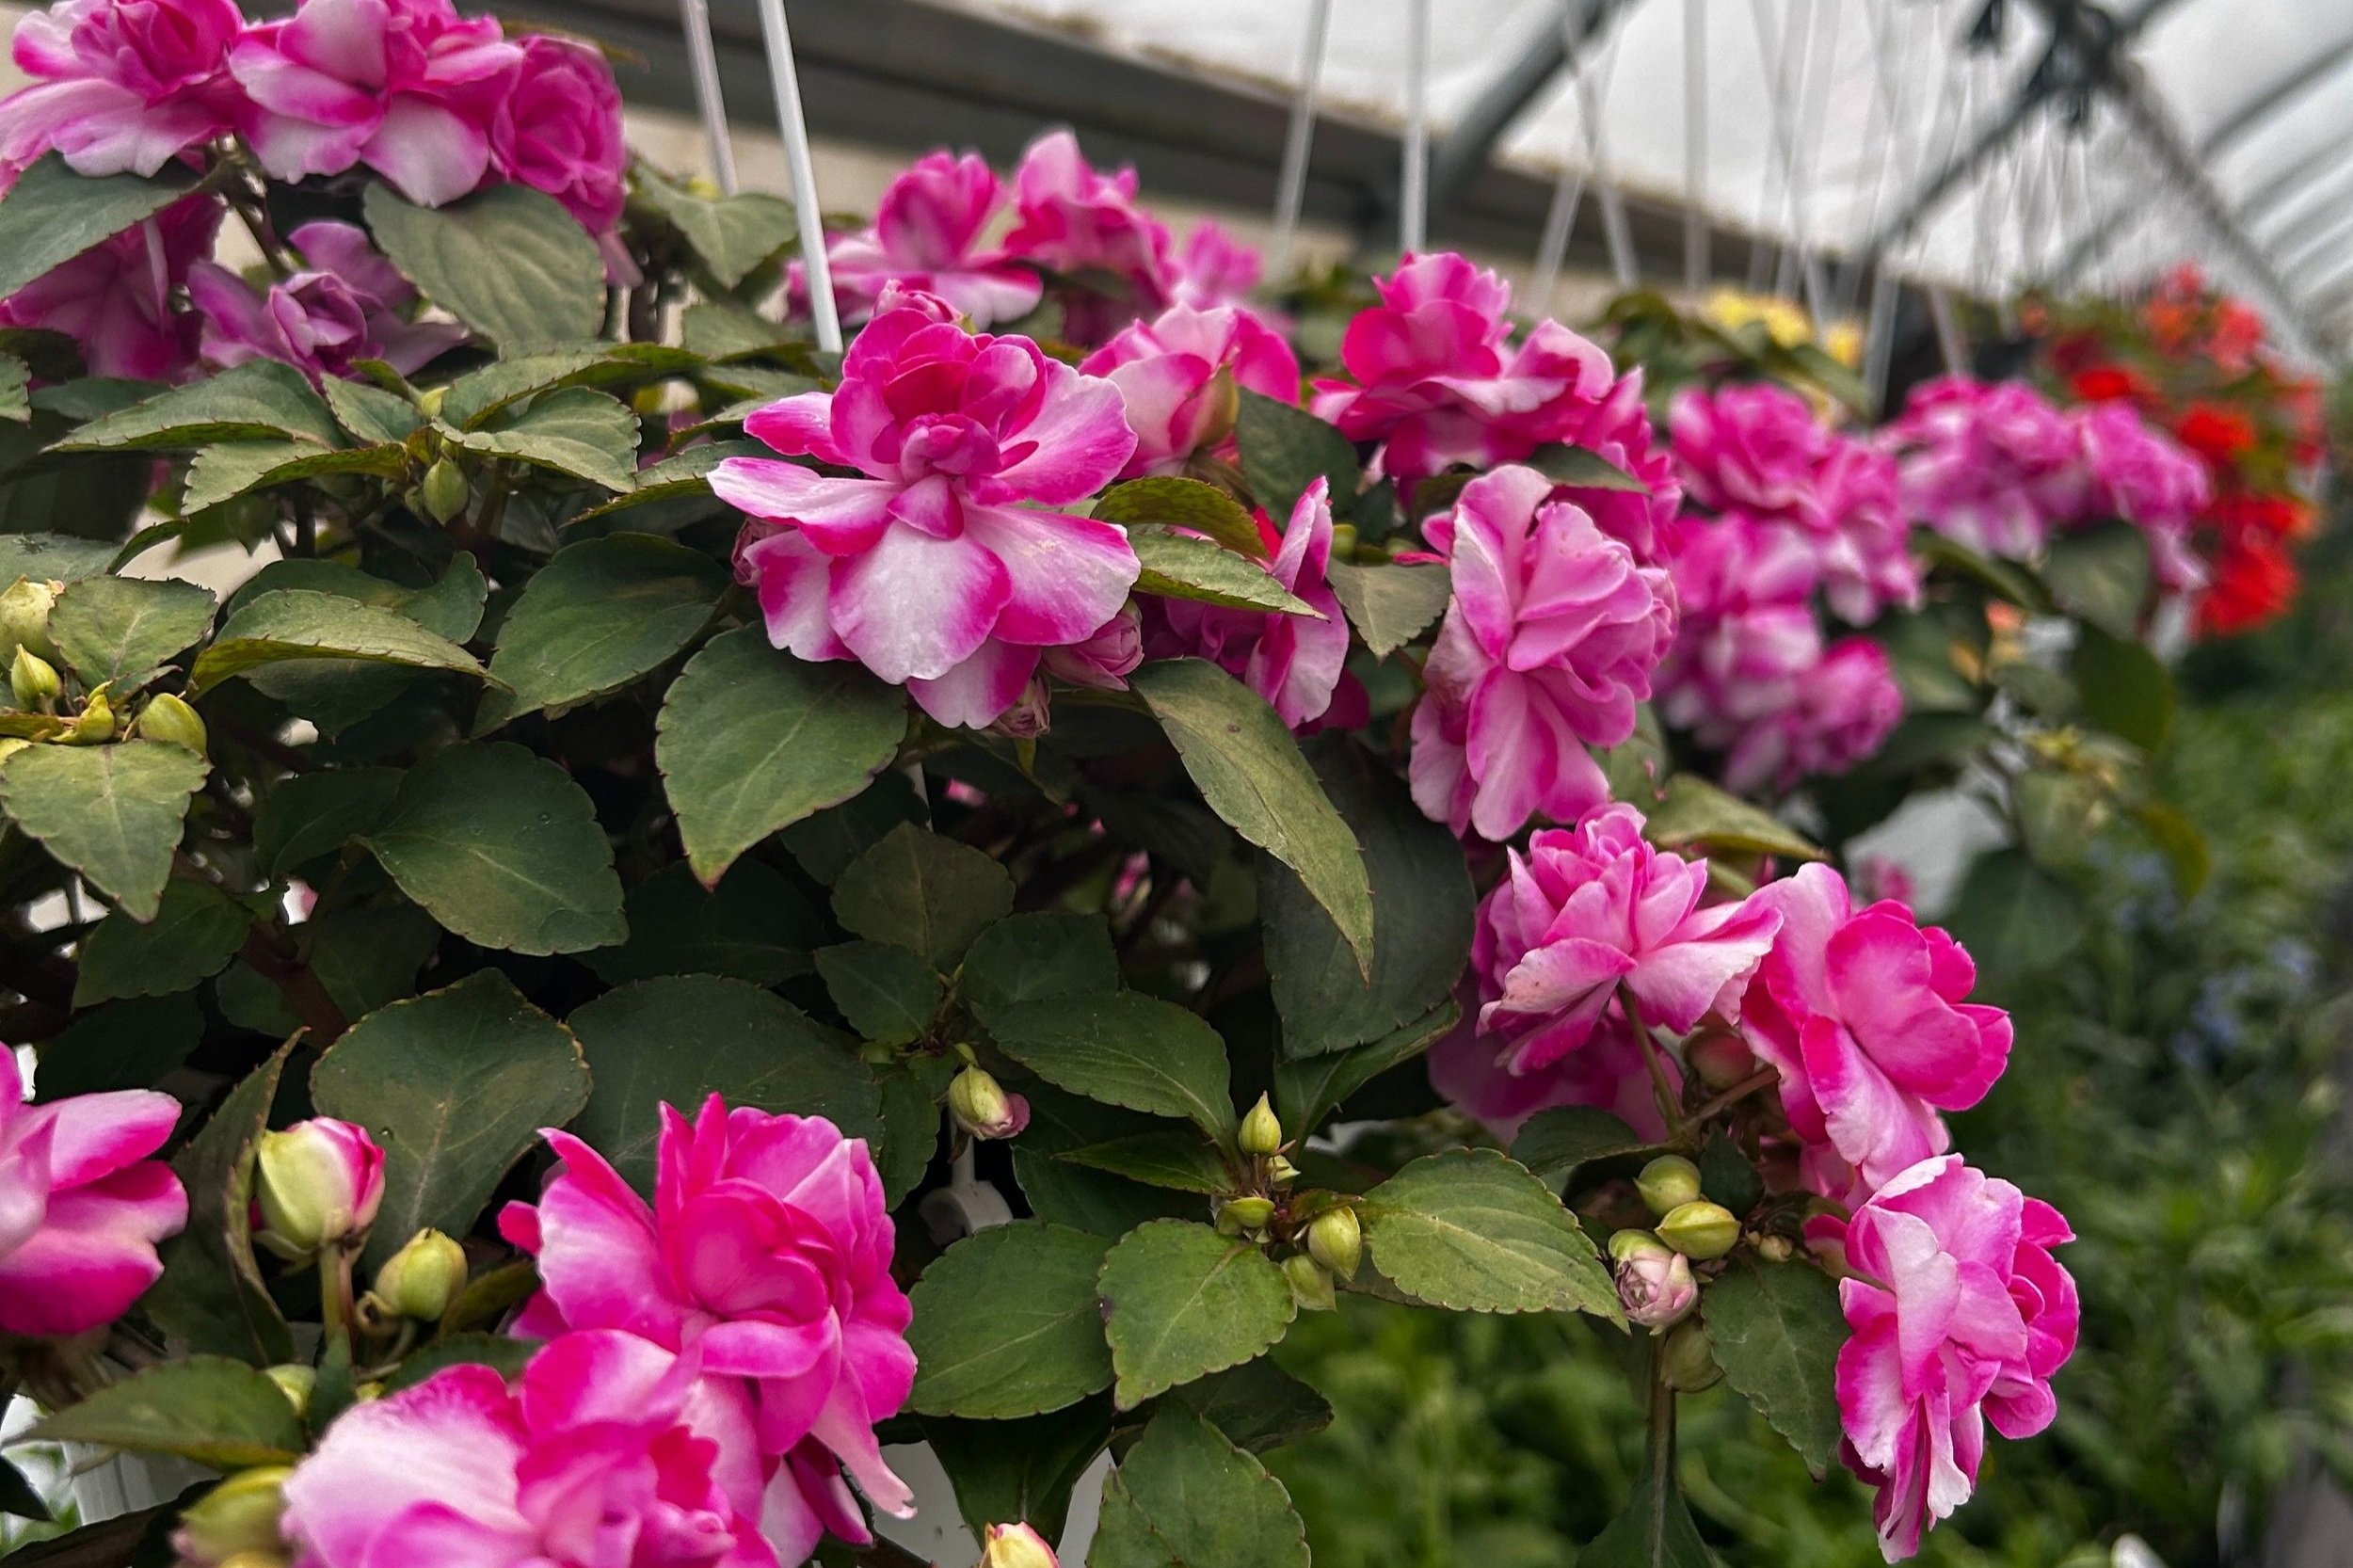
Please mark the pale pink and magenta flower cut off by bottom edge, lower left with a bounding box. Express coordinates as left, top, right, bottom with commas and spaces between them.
282, 1330, 776, 1568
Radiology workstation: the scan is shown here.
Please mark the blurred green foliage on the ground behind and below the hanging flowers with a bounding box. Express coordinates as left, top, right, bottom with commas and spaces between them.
1273, 530, 2353, 1568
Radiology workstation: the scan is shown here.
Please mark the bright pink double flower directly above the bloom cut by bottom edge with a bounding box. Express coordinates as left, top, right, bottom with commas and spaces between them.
499, 1095, 916, 1563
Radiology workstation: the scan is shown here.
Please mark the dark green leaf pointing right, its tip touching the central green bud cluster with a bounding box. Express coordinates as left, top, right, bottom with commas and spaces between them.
988, 991, 1233, 1137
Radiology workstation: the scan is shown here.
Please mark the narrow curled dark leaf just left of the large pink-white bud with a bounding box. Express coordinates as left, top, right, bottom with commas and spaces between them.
139, 1041, 295, 1366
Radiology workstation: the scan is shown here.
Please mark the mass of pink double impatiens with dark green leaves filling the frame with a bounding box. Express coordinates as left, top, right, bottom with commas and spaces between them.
0, 0, 2297, 1568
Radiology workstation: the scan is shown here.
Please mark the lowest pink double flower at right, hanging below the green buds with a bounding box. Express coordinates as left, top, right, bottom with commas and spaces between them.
1817, 1154, 2078, 1560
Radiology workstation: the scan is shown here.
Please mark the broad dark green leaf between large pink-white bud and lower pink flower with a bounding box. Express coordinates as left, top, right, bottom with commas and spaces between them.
311, 970, 588, 1272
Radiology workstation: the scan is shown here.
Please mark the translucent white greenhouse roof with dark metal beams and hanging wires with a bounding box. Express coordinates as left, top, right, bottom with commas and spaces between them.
541, 0, 2353, 358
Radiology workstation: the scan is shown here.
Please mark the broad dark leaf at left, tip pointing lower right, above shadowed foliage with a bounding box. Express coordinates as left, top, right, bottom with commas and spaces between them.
367, 742, 629, 953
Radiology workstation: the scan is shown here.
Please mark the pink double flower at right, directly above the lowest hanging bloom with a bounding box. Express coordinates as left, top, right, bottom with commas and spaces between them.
1741, 867, 2009, 1203
